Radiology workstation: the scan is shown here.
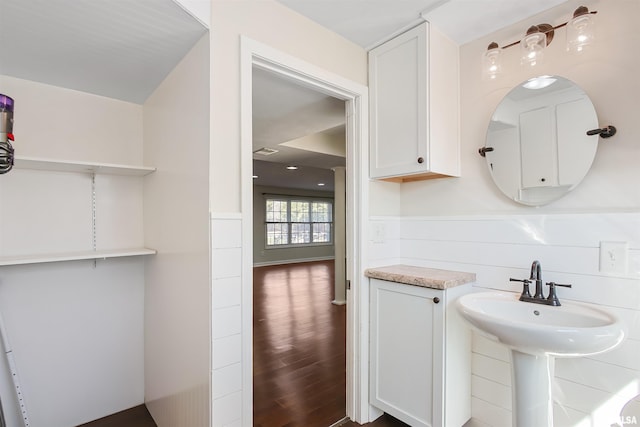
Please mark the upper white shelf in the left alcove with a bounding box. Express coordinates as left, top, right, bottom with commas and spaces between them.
14, 156, 156, 176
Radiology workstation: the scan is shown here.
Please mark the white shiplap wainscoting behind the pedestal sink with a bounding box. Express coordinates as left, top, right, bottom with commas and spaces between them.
369, 212, 640, 427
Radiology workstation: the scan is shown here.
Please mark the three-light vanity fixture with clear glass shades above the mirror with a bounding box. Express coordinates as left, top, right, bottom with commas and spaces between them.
482, 6, 598, 80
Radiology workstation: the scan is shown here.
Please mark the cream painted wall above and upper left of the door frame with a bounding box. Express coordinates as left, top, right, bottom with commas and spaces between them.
210, 0, 367, 212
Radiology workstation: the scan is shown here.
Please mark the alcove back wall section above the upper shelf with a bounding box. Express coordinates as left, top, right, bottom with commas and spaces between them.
0, 75, 142, 165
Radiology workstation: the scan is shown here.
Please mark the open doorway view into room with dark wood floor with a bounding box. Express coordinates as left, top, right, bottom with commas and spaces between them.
252, 61, 348, 427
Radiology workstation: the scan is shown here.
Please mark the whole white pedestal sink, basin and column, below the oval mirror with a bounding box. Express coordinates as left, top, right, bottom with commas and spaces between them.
456, 292, 626, 427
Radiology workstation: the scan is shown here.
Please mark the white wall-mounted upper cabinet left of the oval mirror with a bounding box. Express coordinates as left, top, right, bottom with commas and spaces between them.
369, 22, 460, 182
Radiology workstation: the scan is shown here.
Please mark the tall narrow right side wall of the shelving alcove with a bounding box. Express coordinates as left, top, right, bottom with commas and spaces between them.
144, 34, 211, 427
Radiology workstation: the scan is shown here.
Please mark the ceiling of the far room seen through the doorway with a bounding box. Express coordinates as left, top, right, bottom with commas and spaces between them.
252, 67, 345, 191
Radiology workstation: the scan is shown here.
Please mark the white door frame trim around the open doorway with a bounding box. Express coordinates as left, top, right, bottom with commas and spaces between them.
239, 36, 369, 426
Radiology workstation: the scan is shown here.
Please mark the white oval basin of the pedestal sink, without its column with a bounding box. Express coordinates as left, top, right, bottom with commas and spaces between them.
456, 292, 625, 357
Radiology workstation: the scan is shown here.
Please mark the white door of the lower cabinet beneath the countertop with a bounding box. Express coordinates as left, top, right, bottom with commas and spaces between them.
370, 279, 444, 427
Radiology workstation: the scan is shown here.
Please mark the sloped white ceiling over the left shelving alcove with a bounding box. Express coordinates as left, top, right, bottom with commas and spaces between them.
0, 0, 207, 104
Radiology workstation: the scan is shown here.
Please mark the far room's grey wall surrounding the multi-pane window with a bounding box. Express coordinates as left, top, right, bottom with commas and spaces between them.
253, 185, 334, 266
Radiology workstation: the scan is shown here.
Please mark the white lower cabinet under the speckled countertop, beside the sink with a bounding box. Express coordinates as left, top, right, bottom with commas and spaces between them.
369, 272, 471, 427
